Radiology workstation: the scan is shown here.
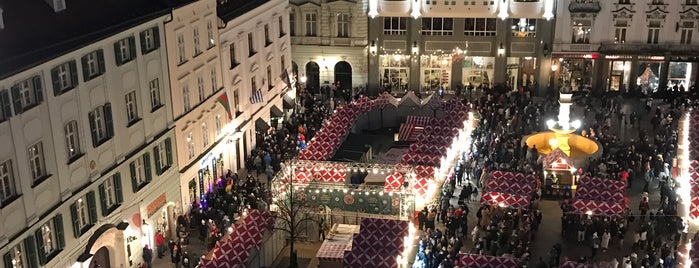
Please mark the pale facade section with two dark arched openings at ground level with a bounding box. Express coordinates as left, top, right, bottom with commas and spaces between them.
289, 0, 369, 98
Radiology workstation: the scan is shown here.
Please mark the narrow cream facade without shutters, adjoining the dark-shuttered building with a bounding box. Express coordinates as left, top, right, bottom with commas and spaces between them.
165, 0, 227, 214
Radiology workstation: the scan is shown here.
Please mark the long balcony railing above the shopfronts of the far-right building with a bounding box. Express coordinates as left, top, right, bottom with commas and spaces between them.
599, 43, 699, 55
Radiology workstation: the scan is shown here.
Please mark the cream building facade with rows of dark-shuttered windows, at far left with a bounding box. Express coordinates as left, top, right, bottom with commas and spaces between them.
0, 7, 181, 267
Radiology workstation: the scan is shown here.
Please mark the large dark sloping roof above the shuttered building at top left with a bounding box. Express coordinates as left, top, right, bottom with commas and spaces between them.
0, 0, 194, 79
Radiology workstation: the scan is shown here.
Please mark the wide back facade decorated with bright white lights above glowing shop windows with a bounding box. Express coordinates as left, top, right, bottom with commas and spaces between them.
367, 0, 556, 96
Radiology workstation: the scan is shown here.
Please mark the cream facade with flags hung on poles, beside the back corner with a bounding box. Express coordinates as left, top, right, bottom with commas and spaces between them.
218, 0, 296, 176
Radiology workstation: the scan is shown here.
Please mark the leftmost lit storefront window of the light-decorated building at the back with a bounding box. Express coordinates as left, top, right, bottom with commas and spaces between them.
379, 54, 410, 92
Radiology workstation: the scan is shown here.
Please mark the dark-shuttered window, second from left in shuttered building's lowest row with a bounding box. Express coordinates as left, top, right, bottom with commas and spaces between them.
37, 214, 65, 266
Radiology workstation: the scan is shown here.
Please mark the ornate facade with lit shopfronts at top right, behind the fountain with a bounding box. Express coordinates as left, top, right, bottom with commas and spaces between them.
548, 0, 699, 93
